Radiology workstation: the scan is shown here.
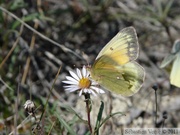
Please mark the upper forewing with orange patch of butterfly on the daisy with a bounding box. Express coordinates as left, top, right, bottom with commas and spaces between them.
96, 27, 139, 65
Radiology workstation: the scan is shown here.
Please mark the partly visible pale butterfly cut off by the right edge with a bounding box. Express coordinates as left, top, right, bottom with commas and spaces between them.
160, 39, 180, 87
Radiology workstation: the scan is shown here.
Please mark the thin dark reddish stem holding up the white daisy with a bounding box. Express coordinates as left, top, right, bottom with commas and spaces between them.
84, 93, 92, 134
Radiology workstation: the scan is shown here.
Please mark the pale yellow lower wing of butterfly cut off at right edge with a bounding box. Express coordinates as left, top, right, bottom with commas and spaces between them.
170, 52, 180, 87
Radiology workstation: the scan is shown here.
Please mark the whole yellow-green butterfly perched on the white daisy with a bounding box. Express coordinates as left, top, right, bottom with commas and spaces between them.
90, 27, 145, 96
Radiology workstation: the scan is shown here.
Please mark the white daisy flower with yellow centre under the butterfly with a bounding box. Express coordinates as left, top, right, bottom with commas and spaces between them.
62, 66, 105, 96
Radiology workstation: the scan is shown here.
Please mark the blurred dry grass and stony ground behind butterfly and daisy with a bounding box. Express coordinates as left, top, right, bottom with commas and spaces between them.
0, 0, 180, 135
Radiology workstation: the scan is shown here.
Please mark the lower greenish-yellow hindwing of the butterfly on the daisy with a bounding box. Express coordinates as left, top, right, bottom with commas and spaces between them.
91, 56, 145, 96
